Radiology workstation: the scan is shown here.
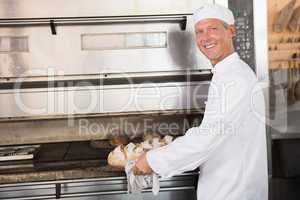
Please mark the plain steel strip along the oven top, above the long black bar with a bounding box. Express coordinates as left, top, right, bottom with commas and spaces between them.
0, 0, 213, 18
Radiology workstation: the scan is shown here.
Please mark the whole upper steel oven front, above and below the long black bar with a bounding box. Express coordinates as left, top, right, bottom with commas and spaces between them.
0, 0, 213, 77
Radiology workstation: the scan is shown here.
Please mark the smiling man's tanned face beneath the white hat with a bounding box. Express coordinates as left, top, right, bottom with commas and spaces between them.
195, 19, 235, 65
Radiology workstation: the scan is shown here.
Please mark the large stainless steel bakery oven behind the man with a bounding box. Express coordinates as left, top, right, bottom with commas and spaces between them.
0, 0, 267, 200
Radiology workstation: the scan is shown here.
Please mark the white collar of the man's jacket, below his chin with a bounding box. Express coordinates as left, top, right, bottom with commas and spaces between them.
211, 52, 240, 73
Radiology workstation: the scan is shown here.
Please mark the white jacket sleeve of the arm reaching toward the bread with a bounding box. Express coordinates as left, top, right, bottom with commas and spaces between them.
146, 75, 250, 177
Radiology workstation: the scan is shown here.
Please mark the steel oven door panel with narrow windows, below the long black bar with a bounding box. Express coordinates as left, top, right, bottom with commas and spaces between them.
0, 18, 210, 78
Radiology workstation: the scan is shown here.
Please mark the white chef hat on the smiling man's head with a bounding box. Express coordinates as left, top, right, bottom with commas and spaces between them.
193, 4, 234, 25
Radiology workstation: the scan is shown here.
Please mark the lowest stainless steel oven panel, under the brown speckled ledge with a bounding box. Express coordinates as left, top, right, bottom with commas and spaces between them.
0, 172, 197, 200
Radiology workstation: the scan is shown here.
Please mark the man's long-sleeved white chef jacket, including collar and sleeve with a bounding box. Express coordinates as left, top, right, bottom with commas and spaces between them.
146, 53, 268, 200
